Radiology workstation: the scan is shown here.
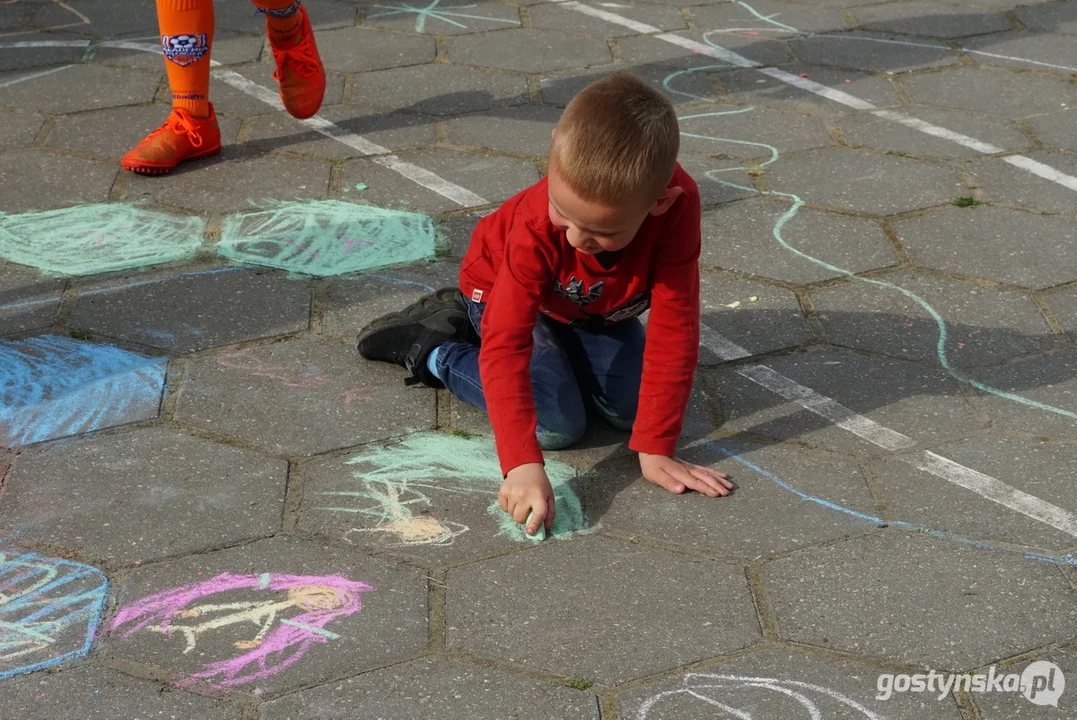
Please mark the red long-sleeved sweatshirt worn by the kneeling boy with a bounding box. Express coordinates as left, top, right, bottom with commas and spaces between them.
460, 165, 700, 474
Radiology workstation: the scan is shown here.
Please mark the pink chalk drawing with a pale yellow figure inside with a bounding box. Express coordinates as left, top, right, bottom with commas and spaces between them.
112, 573, 373, 688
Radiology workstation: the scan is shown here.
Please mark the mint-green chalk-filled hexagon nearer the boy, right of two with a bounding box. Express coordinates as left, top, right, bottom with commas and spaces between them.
218, 200, 434, 277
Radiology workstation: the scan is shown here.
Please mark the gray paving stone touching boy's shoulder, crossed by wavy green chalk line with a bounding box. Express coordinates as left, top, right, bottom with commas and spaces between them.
701, 198, 897, 284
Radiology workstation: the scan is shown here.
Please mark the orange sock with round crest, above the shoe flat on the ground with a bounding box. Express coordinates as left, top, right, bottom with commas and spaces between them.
157, 0, 213, 117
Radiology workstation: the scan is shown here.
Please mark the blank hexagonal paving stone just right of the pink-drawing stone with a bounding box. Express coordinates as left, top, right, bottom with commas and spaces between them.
445, 537, 760, 684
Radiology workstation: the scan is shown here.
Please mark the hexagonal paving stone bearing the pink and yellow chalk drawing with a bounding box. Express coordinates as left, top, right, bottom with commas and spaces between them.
106, 538, 426, 695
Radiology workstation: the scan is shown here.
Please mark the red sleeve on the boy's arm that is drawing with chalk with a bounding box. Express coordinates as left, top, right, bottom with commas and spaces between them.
478, 221, 553, 475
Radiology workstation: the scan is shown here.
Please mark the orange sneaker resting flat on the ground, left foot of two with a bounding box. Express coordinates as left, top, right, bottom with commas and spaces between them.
120, 103, 221, 175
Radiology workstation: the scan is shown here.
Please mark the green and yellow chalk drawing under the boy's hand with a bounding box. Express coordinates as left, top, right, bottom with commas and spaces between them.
316, 433, 593, 546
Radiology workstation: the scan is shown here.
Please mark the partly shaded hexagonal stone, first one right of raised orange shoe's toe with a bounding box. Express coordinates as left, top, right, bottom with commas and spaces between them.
350, 62, 530, 115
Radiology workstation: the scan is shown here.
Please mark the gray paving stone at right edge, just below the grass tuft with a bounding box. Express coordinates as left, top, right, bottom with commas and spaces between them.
894, 204, 1077, 287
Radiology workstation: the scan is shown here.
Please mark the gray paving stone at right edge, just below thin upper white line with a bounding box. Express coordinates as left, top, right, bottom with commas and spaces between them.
901, 68, 1077, 117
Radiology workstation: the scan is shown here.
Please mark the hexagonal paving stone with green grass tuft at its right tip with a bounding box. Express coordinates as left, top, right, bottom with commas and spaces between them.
767, 149, 967, 215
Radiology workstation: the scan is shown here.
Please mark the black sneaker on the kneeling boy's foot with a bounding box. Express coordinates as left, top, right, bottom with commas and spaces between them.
356, 287, 477, 387
